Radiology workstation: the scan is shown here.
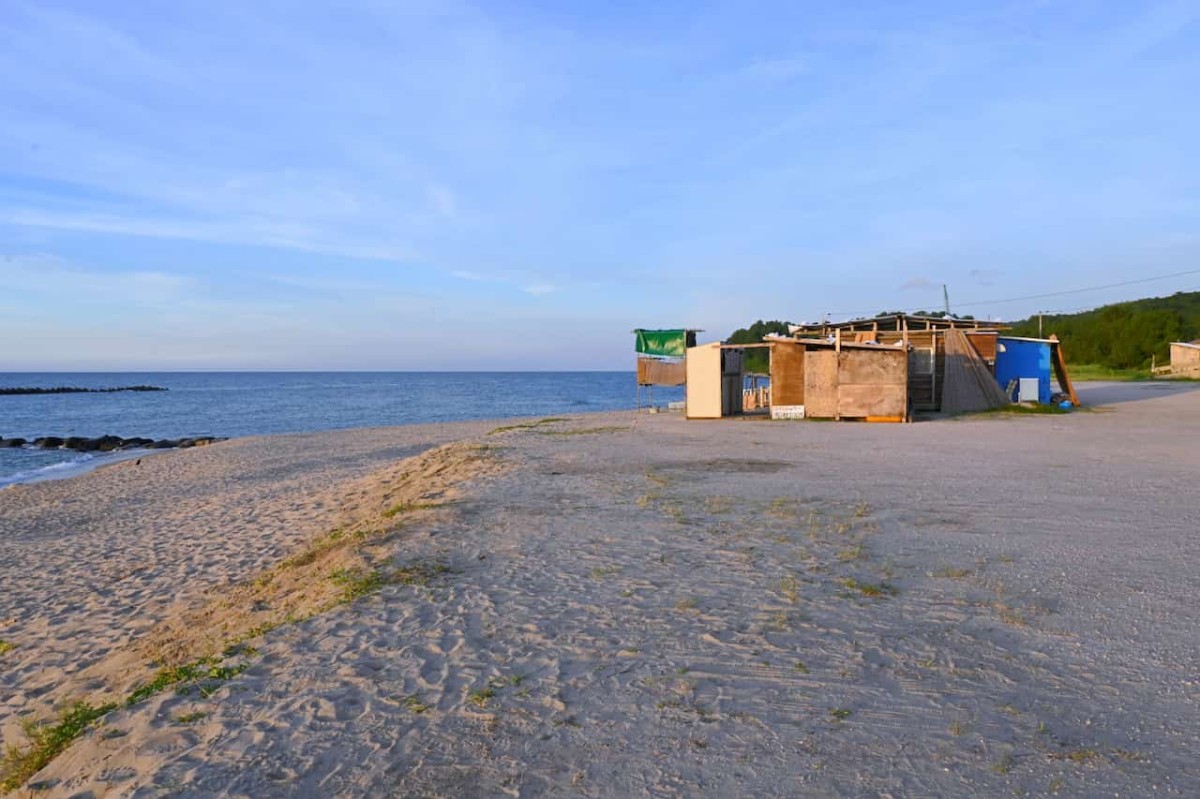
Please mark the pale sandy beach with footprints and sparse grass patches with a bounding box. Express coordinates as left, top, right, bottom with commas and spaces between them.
0, 384, 1200, 798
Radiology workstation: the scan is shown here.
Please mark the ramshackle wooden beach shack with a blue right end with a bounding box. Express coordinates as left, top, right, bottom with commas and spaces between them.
685, 313, 1084, 422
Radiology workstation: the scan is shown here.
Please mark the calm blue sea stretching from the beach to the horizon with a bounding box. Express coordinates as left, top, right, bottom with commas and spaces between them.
0, 371, 683, 487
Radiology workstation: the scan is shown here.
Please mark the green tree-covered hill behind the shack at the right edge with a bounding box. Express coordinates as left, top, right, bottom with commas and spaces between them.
1009, 292, 1200, 370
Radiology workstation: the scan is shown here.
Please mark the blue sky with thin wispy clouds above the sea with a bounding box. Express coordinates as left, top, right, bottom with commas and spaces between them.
0, 0, 1200, 371
